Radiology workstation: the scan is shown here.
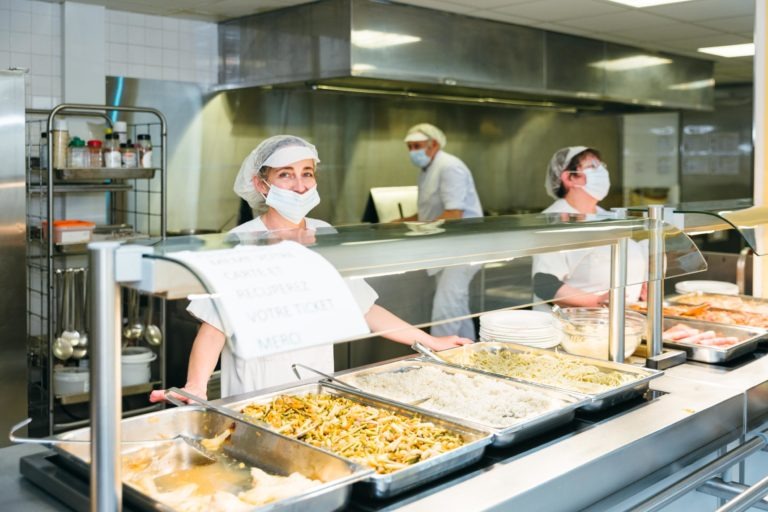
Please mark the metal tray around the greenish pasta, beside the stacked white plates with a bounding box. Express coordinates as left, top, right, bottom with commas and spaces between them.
428, 341, 664, 411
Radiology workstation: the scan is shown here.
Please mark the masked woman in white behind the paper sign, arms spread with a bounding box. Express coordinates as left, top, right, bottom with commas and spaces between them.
150, 135, 471, 402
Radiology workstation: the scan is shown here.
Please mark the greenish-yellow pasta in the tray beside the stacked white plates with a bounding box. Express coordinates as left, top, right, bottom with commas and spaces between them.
443, 350, 634, 394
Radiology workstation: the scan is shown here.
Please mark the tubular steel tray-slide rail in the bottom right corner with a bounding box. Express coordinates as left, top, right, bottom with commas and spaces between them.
631, 430, 768, 512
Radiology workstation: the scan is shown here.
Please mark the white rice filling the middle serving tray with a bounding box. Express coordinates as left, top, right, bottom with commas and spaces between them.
341, 366, 566, 428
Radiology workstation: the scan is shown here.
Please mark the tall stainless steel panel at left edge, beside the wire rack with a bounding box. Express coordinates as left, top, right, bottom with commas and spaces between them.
0, 71, 27, 446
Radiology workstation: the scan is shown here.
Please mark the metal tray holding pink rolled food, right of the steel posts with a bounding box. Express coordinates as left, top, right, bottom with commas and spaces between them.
663, 317, 766, 363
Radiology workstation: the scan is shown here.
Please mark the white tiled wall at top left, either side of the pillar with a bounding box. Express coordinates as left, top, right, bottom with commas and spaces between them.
0, 0, 218, 108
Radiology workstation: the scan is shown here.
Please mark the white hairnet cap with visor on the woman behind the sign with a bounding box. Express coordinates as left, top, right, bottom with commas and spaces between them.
233, 135, 320, 208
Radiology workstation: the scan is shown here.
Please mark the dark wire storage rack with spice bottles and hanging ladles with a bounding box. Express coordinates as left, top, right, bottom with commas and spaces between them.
26, 104, 167, 435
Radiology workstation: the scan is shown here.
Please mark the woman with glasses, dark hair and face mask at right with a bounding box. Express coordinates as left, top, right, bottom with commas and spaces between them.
533, 146, 648, 310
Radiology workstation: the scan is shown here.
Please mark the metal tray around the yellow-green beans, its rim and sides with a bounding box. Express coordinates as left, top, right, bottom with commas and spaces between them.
226, 382, 493, 498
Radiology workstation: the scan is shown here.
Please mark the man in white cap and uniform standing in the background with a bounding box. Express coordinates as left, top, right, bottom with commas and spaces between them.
404, 123, 483, 339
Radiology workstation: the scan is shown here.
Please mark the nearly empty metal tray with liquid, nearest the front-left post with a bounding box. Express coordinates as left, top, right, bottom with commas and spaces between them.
53, 406, 371, 512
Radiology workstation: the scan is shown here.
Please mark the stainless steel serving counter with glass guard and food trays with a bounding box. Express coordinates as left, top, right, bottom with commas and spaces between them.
7, 207, 768, 510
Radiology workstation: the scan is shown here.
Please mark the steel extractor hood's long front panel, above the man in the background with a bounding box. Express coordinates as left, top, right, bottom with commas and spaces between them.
350, 2, 544, 90
